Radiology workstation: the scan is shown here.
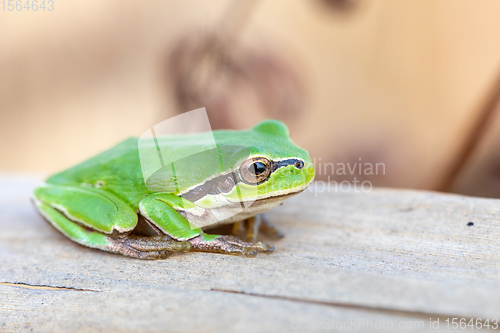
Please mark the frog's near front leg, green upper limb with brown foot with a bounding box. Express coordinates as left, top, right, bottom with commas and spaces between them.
139, 193, 274, 257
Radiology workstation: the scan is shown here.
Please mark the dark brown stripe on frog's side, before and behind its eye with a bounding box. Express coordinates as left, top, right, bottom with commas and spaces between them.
181, 158, 302, 202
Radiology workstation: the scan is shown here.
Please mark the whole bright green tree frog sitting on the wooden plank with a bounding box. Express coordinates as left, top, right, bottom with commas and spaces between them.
33, 120, 314, 259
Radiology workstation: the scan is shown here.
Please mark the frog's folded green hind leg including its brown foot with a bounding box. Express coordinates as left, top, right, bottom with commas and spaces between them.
33, 184, 190, 259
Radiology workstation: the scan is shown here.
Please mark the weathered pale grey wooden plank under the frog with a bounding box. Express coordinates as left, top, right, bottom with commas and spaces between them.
0, 175, 500, 332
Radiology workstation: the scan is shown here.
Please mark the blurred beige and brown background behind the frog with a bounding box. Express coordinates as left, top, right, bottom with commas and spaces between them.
0, 0, 500, 197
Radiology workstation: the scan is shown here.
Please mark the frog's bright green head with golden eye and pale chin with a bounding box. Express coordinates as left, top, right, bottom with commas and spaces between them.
207, 120, 314, 202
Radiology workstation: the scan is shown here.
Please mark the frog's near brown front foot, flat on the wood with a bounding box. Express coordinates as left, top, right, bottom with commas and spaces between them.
189, 234, 274, 257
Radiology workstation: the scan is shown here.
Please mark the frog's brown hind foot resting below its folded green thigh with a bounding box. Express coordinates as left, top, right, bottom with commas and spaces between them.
108, 235, 191, 259
